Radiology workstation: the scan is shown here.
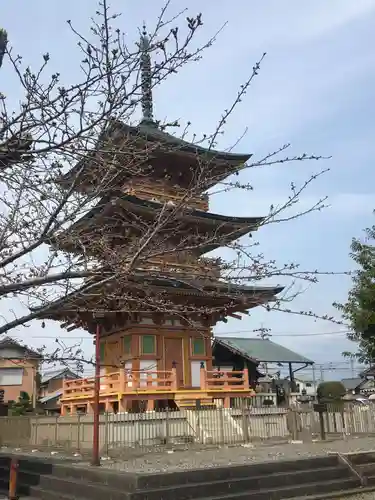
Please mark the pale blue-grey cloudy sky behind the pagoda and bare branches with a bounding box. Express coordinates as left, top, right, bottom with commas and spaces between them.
0, 0, 375, 375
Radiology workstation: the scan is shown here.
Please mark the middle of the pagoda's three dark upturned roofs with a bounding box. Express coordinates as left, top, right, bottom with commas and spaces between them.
55, 192, 264, 255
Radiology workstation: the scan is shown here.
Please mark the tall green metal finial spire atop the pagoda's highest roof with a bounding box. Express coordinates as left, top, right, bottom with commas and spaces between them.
140, 24, 154, 127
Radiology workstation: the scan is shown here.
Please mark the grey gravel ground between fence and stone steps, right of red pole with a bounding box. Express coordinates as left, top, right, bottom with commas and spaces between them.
96, 437, 375, 472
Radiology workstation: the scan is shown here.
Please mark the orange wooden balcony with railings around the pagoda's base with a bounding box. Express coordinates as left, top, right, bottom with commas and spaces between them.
61, 368, 253, 414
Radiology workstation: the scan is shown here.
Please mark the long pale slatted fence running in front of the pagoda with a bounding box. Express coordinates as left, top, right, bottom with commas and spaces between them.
0, 405, 375, 455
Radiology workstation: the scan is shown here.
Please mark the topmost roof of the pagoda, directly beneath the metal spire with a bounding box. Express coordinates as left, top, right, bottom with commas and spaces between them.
60, 120, 252, 192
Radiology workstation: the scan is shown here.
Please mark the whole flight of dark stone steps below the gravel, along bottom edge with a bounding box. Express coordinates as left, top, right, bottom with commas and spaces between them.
0, 456, 352, 500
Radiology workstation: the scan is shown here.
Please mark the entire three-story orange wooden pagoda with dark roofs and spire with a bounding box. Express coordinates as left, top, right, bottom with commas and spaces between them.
39, 35, 282, 414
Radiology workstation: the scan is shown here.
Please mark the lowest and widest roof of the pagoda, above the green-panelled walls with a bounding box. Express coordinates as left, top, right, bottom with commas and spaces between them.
34, 272, 284, 328
